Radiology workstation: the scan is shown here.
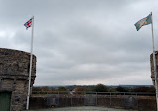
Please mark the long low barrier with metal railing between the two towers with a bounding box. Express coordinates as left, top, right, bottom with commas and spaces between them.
30, 91, 156, 111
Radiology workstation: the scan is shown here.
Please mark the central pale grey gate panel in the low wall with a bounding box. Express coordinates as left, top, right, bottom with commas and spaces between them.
84, 94, 97, 106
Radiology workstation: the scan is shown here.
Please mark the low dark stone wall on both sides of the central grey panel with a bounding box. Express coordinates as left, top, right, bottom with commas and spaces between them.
30, 95, 156, 111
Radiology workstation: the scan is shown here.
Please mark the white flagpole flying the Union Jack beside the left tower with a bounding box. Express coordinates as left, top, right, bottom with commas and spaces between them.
26, 16, 34, 110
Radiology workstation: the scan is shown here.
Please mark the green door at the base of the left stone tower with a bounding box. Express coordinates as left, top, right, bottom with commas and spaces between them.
0, 92, 11, 111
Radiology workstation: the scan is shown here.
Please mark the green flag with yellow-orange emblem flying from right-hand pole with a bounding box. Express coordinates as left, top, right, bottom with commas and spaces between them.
134, 14, 152, 31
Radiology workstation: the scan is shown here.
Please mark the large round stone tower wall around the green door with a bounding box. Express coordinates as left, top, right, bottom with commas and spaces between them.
0, 48, 36, 111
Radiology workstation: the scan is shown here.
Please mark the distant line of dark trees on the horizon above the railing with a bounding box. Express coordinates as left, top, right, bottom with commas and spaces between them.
32, 84, 155, 93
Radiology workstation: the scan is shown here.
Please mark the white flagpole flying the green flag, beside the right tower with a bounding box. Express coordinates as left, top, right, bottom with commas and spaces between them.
151, 12, 158, 111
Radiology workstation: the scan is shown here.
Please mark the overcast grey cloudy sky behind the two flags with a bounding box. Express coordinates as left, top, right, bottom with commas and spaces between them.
0, 0, 158, 85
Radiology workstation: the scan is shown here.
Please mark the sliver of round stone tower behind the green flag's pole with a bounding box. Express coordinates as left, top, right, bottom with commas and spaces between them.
150, 51, 158, 85
